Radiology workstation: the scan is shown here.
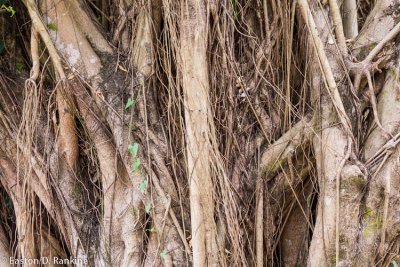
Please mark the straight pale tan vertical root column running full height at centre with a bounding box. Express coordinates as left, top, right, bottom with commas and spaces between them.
180, 0, 220, 266
